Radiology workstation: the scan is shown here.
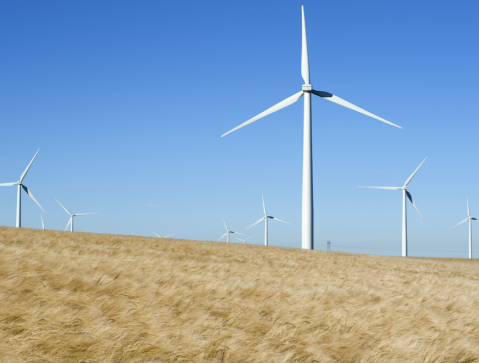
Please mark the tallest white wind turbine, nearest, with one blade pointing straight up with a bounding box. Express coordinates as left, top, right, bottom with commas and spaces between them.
221, 7, 401, 249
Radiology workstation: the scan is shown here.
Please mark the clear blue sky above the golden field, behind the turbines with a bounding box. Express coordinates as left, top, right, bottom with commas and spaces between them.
0, 0, 479, 257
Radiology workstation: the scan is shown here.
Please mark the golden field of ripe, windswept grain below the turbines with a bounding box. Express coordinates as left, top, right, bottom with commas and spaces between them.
0, 227, 479, 363
